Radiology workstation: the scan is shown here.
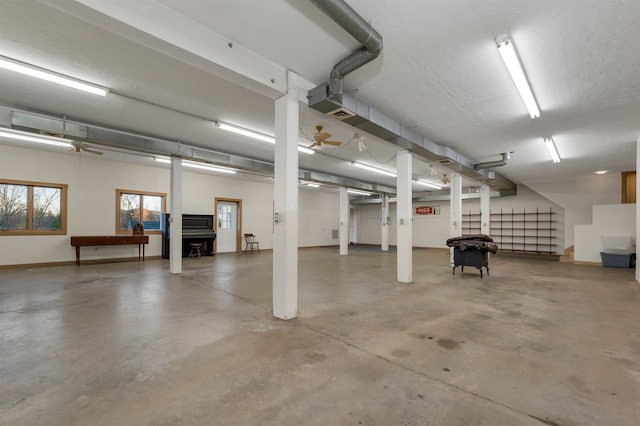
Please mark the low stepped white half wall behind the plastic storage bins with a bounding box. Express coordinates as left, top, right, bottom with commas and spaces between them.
574, 204, 636, 263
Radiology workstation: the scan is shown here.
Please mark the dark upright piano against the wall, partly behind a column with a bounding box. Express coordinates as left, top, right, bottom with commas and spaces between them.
160, 213, 216, 259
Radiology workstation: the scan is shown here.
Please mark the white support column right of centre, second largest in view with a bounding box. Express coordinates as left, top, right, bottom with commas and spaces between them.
396, 151, 413, 283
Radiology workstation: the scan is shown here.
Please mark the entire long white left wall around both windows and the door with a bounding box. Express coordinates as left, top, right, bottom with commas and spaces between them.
0, 145, 339, 265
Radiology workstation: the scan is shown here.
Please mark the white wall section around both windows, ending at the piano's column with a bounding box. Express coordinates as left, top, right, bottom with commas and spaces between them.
0, 146, 169, 265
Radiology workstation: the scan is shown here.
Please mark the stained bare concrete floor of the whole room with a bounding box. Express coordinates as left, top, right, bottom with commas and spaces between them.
0, 248, 640, 426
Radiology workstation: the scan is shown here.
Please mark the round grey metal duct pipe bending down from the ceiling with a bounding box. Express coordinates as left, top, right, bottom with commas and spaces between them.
309, 0, 382, 102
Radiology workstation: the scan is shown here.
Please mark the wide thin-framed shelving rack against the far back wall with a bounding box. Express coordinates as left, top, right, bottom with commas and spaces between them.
462, 208, 557, 255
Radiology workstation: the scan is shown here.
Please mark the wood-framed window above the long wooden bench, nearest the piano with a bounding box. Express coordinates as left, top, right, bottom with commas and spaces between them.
116, 189, 167, 234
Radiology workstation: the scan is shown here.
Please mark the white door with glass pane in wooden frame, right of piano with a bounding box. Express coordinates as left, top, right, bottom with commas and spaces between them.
215, 198, 242, 253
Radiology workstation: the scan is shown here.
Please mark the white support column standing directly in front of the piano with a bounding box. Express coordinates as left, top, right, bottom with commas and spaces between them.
169, 157, 182, 274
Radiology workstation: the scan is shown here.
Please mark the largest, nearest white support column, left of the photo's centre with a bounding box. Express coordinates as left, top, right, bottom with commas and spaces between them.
273, 71, 300, 320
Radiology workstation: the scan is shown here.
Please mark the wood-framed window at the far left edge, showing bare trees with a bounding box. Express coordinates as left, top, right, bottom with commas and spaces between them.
0, 180, 67, 235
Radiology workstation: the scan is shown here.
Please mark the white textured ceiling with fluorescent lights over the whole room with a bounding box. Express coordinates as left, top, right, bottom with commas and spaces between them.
0, 0, 640, 191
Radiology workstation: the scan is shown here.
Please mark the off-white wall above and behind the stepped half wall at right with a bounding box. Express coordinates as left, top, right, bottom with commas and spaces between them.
527, 173, 622, 248
